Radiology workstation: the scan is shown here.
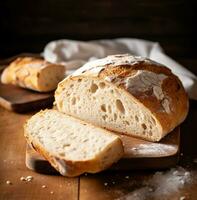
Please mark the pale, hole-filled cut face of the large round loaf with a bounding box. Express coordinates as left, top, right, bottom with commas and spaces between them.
56, 77, 162, 141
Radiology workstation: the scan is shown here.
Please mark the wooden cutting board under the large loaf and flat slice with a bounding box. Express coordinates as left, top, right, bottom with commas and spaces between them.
26, 127, 180, 174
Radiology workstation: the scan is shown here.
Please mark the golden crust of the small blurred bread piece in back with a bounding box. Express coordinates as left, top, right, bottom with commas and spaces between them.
1, 57, 65, 92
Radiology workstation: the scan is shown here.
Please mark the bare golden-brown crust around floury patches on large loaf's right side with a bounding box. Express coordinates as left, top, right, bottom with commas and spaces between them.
99, 62, 188, 138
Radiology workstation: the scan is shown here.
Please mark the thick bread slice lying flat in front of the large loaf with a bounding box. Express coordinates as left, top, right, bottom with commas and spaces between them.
24, 110, 123, 177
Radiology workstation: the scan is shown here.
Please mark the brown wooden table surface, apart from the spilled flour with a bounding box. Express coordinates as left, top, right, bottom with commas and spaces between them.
0, 102, 197, 200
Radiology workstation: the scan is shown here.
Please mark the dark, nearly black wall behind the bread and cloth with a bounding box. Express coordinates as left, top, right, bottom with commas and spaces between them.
0, 0, 197, 62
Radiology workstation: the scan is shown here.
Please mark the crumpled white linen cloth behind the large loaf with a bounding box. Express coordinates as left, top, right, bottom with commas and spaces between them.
43, 38, 197, 100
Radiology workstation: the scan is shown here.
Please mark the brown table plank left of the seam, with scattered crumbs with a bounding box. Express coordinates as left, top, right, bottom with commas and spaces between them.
0, 107, 79, 200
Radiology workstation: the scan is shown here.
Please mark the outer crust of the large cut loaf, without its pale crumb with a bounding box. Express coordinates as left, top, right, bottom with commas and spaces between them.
55, 55, 189, 141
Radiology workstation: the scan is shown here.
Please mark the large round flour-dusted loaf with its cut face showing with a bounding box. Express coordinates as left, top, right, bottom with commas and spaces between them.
55, 54, 188, 141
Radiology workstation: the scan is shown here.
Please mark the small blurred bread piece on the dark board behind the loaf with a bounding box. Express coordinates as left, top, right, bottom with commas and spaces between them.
1, 57, 65, 92
